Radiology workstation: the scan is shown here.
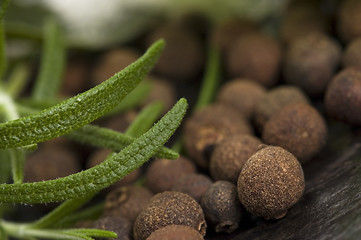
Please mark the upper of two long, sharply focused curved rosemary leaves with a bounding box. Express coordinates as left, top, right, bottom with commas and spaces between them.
0, 40, 164, 148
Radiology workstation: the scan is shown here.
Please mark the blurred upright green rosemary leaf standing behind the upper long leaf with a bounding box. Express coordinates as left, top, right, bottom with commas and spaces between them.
32, 18, 66, 100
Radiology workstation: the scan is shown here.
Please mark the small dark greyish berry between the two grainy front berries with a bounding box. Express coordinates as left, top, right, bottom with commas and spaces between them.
200, 181, 242, 233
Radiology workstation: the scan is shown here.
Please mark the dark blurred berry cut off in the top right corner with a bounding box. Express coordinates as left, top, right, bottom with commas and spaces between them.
336, 0, 361, 42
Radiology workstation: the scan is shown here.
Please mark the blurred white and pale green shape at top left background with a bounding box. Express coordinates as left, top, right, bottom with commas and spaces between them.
43, 0, 167, 47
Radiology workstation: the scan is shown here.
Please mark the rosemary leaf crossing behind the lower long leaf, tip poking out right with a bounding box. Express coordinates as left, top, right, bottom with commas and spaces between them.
66, 125, 179, 159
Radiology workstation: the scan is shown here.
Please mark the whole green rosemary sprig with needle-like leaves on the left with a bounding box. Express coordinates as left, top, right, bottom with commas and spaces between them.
0, 0, 187, 240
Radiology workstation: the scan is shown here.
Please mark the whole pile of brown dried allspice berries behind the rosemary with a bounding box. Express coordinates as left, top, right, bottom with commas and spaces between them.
20, 0, 361, 240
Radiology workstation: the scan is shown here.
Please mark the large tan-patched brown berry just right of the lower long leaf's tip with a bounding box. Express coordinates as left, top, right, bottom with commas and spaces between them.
184, 104, 253, 168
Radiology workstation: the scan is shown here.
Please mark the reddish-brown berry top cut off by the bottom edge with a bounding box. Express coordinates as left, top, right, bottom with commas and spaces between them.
147, 225, 204, 240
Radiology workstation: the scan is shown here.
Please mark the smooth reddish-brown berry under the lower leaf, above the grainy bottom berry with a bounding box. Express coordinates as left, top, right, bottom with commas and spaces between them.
145, 156, 197, 193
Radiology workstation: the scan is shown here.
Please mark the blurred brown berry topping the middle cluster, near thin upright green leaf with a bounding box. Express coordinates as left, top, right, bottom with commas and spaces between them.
217, 78, 266, 119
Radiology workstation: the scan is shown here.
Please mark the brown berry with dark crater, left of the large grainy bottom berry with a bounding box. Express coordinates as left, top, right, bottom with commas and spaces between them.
104, 185, 153, 223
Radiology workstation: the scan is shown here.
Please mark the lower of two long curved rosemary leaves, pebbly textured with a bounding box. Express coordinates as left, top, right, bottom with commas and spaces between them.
0, 99, 187, 203
